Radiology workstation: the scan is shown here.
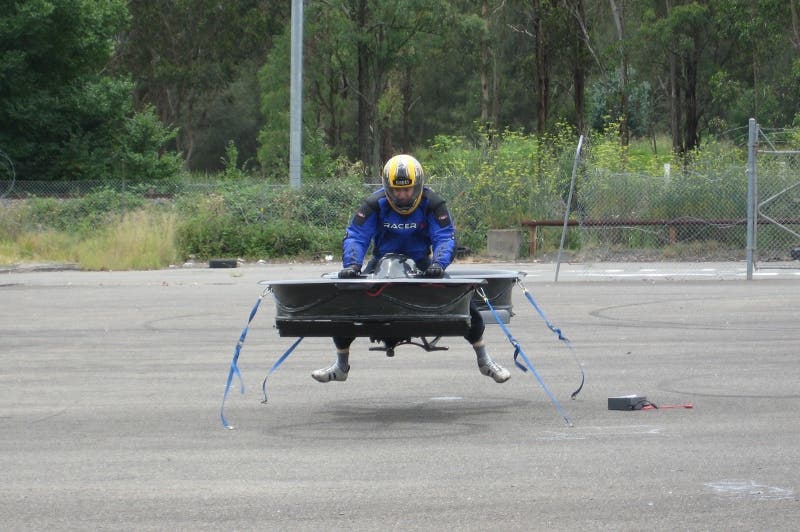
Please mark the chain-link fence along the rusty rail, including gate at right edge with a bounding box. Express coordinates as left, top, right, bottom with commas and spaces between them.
523, 125, 800, 268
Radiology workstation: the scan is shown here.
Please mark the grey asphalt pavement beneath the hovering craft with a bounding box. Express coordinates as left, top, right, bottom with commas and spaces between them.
0, 263, 800, 531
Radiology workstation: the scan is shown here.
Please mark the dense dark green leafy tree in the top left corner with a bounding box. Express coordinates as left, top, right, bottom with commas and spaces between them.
0, 0, 137, 180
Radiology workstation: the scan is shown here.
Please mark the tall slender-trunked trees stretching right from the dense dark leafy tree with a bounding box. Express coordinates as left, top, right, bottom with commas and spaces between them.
114, 0, 800, 175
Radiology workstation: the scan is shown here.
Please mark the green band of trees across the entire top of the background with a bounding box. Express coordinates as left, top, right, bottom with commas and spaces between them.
6, 0, 800, 184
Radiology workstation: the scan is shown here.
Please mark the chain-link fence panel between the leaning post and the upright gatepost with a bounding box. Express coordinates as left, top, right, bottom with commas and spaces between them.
574, 165, 747, 262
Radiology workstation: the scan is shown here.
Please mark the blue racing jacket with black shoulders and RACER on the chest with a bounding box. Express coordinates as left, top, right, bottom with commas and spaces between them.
342, 187, 456, 270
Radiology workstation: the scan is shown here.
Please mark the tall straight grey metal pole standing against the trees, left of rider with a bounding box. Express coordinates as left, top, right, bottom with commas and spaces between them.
289, 0, 303, 188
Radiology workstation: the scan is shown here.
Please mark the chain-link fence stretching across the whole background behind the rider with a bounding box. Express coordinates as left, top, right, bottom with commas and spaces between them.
0, 121, 800, 268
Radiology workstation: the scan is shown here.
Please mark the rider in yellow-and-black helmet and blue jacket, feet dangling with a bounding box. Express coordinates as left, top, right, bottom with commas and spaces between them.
311, 155, 511, 382
